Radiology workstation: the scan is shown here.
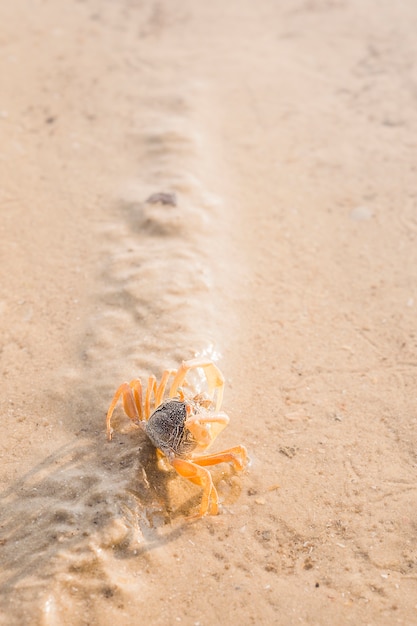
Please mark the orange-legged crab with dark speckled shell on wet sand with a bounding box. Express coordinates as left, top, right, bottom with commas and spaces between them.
106, 358, 248, 519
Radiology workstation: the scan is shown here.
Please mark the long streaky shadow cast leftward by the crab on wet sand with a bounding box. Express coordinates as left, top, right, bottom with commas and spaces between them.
0, 416, 190, 599
